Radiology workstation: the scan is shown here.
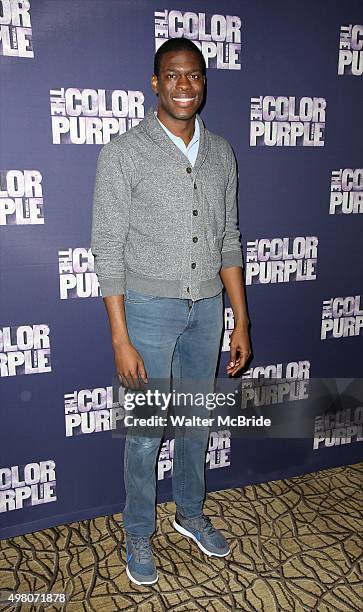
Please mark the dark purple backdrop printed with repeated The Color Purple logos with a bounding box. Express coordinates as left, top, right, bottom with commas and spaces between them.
0, 0, 363, 537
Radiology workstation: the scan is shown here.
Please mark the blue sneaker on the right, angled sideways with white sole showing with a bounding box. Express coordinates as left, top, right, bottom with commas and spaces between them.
173, 512, 231, 557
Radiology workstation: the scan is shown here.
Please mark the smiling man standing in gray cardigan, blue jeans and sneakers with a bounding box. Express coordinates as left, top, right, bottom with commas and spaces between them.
91, 38, 251, 584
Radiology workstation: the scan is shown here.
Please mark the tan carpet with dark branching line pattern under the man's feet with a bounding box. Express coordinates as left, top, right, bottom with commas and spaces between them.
0, 464, 363, 612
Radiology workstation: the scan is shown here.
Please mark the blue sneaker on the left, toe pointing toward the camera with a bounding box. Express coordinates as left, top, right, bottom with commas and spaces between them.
126, 534, 159, 584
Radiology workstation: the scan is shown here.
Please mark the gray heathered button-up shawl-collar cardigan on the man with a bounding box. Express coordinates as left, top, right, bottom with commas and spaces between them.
91, 108, 243, 300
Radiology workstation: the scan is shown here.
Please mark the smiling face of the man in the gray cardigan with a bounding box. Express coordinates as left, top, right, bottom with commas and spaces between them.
151, 50, 205, 120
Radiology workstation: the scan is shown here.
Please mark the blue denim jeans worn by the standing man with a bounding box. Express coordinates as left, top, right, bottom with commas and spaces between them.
123, 290, 223, 536
